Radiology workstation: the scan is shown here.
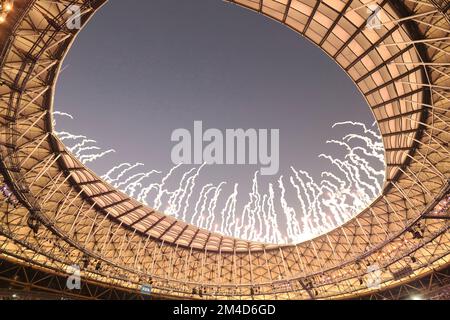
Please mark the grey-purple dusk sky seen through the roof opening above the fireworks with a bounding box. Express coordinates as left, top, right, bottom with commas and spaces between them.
55, 0, 382, 240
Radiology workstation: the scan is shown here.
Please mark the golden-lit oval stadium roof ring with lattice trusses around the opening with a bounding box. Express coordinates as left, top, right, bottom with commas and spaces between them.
0, 0, 450, 299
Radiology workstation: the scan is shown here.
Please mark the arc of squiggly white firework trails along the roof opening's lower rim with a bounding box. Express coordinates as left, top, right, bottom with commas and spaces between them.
57, 113, 384, 243
